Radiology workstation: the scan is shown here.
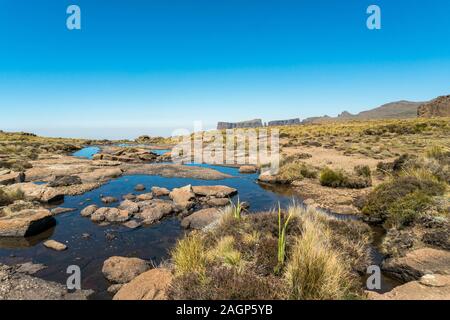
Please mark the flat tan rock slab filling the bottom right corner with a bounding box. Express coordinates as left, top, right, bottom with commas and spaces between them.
368, 275, 450, 300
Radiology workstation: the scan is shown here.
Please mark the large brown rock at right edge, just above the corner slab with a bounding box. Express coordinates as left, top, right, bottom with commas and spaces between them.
383, 248, 450, 282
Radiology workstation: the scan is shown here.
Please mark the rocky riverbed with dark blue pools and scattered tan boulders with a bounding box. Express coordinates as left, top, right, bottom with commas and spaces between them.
0, 146, 450, 299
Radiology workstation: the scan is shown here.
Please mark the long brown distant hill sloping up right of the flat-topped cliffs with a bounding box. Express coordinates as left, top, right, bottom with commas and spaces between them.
302, 100, 423, 123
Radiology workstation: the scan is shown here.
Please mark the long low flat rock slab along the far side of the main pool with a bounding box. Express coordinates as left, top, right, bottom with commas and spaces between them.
121, 164, 232, 180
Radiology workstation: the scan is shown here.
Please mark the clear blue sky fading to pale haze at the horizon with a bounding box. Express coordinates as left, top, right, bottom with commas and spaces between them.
0, 0, 450, 139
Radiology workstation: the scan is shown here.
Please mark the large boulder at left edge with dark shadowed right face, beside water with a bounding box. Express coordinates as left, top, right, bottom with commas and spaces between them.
0, 208, 55, 237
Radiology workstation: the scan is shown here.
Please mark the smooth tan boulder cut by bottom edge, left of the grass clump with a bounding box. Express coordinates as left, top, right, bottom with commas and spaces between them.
113, 268, 172, 300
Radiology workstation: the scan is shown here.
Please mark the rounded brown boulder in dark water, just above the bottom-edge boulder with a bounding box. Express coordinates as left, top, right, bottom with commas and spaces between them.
102, 256, 150, 283
